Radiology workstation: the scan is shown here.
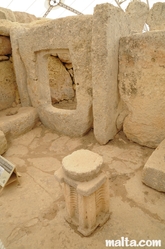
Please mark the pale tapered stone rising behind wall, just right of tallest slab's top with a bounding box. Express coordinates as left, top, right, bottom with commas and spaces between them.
126, 1, 149, 33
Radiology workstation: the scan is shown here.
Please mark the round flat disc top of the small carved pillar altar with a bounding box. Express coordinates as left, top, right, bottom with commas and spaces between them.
62, 149, 103, 181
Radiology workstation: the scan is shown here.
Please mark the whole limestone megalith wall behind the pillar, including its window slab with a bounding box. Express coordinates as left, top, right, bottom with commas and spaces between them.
0, 1, 165, 147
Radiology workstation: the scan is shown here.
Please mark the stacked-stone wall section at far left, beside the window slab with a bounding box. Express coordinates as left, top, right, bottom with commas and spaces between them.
0, 8, 36, 110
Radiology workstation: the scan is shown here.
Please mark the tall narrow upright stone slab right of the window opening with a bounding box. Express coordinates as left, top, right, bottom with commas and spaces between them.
92, 3, 129, 144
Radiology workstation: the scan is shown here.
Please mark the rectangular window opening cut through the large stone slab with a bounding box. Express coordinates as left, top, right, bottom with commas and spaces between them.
48, 49, 77, 110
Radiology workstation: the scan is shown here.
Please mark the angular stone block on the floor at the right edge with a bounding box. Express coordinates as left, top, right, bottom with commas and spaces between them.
142, 140, 165, 192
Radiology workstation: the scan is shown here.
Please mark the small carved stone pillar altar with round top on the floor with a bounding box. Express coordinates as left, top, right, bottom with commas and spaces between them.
55, 149, 110, 236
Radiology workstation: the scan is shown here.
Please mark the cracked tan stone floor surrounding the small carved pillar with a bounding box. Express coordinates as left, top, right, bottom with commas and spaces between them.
0, 125, 165, 249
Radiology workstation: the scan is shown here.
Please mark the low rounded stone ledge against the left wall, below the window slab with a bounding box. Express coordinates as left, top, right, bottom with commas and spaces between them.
0, 107, 38, 137
